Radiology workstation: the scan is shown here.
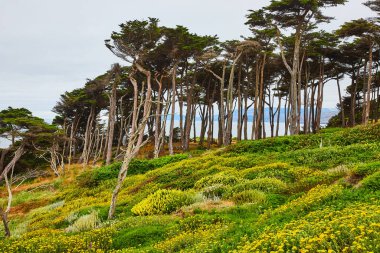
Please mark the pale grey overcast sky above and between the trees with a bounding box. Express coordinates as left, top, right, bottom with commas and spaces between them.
0, 0, 373, 121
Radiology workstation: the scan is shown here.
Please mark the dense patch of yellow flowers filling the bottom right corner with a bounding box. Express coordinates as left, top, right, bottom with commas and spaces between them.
236, 203, 380, 253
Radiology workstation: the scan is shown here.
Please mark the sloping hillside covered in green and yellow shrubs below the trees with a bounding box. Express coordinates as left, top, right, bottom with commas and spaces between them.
0, 124, 380, 252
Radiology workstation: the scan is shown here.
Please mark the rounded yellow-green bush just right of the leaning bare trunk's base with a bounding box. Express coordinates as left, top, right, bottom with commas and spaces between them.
131, 190, 193, 215
